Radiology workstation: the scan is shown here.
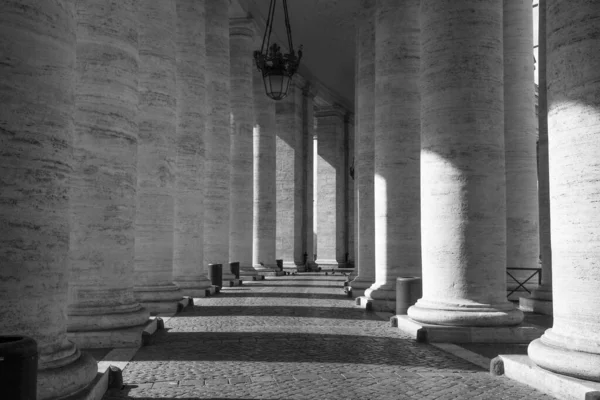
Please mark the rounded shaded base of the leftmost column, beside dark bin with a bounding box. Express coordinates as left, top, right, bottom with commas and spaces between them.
37, 348, 98, 400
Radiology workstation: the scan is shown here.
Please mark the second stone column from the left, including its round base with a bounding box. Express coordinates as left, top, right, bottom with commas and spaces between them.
67, 0, 149, 348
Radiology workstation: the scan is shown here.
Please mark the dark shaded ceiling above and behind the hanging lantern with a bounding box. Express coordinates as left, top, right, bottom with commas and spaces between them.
232, 0, 360, 111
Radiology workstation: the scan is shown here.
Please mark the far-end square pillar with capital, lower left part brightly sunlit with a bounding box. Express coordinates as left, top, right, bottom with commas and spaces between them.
315, 106, 346, 268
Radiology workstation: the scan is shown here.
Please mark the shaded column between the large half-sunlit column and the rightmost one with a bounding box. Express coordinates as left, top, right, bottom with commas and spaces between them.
504, 0, 540, 294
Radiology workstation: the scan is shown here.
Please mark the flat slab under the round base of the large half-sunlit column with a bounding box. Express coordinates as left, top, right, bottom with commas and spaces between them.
390, 315, 544, 344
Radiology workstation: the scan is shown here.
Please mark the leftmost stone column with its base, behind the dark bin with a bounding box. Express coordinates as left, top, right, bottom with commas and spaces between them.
0, 0, 97, 400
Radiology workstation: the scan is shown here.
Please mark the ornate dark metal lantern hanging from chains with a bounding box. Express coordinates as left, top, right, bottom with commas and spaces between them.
254, 0, 302, 100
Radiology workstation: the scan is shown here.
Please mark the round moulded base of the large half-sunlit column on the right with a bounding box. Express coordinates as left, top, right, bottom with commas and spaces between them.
408, 298, 524, 327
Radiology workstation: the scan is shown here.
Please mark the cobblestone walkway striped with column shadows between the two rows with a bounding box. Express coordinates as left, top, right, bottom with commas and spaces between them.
104, 274, 550, 400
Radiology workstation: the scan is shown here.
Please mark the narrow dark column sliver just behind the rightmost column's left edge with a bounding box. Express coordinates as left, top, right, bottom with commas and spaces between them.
531, 0, 552, 301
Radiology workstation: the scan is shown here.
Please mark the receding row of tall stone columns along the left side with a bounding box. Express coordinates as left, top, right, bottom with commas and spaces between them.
0, 0, 345, 400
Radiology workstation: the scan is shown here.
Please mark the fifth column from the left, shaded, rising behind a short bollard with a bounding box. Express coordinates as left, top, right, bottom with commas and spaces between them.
204, 0, 236, 280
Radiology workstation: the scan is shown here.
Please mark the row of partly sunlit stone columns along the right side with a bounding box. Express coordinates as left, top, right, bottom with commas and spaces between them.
352, 0, 600, 381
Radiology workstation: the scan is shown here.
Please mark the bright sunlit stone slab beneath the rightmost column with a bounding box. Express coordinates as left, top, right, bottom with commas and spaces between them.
490, 354, 600, 400
